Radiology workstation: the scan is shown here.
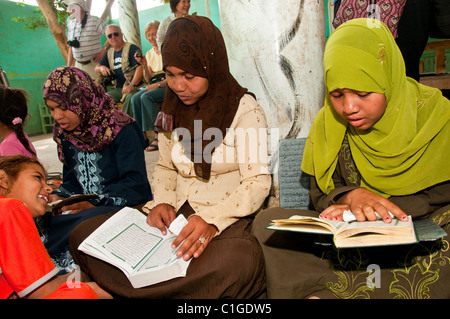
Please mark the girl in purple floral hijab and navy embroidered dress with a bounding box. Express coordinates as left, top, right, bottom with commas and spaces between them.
43, 67, 152, 271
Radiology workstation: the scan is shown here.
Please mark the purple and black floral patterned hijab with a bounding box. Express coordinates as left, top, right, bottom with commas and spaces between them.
43, 67, 134, 163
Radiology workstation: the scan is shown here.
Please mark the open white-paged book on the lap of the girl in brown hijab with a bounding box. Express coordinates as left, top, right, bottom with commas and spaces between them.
78, 207, 190, 288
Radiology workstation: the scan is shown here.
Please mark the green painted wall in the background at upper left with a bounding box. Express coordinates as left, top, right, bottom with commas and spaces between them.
0, 0, 220, 136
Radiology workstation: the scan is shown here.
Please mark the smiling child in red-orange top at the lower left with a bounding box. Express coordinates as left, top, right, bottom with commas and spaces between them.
0, 155, 105, 299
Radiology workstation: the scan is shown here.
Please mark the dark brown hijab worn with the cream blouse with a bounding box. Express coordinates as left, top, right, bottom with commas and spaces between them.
157, 16, 247, 180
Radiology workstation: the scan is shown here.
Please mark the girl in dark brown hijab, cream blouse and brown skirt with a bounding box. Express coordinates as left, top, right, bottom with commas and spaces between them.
71, 16, 271, 298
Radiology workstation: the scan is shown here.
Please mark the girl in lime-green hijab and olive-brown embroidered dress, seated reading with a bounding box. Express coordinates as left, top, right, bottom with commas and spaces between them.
253, 19, 450, 298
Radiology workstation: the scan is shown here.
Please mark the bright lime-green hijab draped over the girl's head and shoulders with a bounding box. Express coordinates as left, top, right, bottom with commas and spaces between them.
302, 19, 450, 197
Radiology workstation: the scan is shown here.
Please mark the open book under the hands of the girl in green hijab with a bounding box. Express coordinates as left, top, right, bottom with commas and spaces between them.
267, 215, 446, 248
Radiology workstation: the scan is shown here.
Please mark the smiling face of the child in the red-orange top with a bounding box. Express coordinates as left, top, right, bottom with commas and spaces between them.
3, 164, 52, 218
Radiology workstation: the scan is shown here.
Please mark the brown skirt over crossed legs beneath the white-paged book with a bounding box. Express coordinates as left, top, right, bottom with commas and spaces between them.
70, 205, 266, 299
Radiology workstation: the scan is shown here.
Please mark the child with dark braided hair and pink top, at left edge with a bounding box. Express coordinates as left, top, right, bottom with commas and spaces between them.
0, 85, 36, 157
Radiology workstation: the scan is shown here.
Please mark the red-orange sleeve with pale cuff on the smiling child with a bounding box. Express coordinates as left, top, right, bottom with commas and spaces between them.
0, 197, 59, 298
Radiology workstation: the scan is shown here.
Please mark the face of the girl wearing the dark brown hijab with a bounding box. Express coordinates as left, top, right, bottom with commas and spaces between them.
166, 66, 209, 105
